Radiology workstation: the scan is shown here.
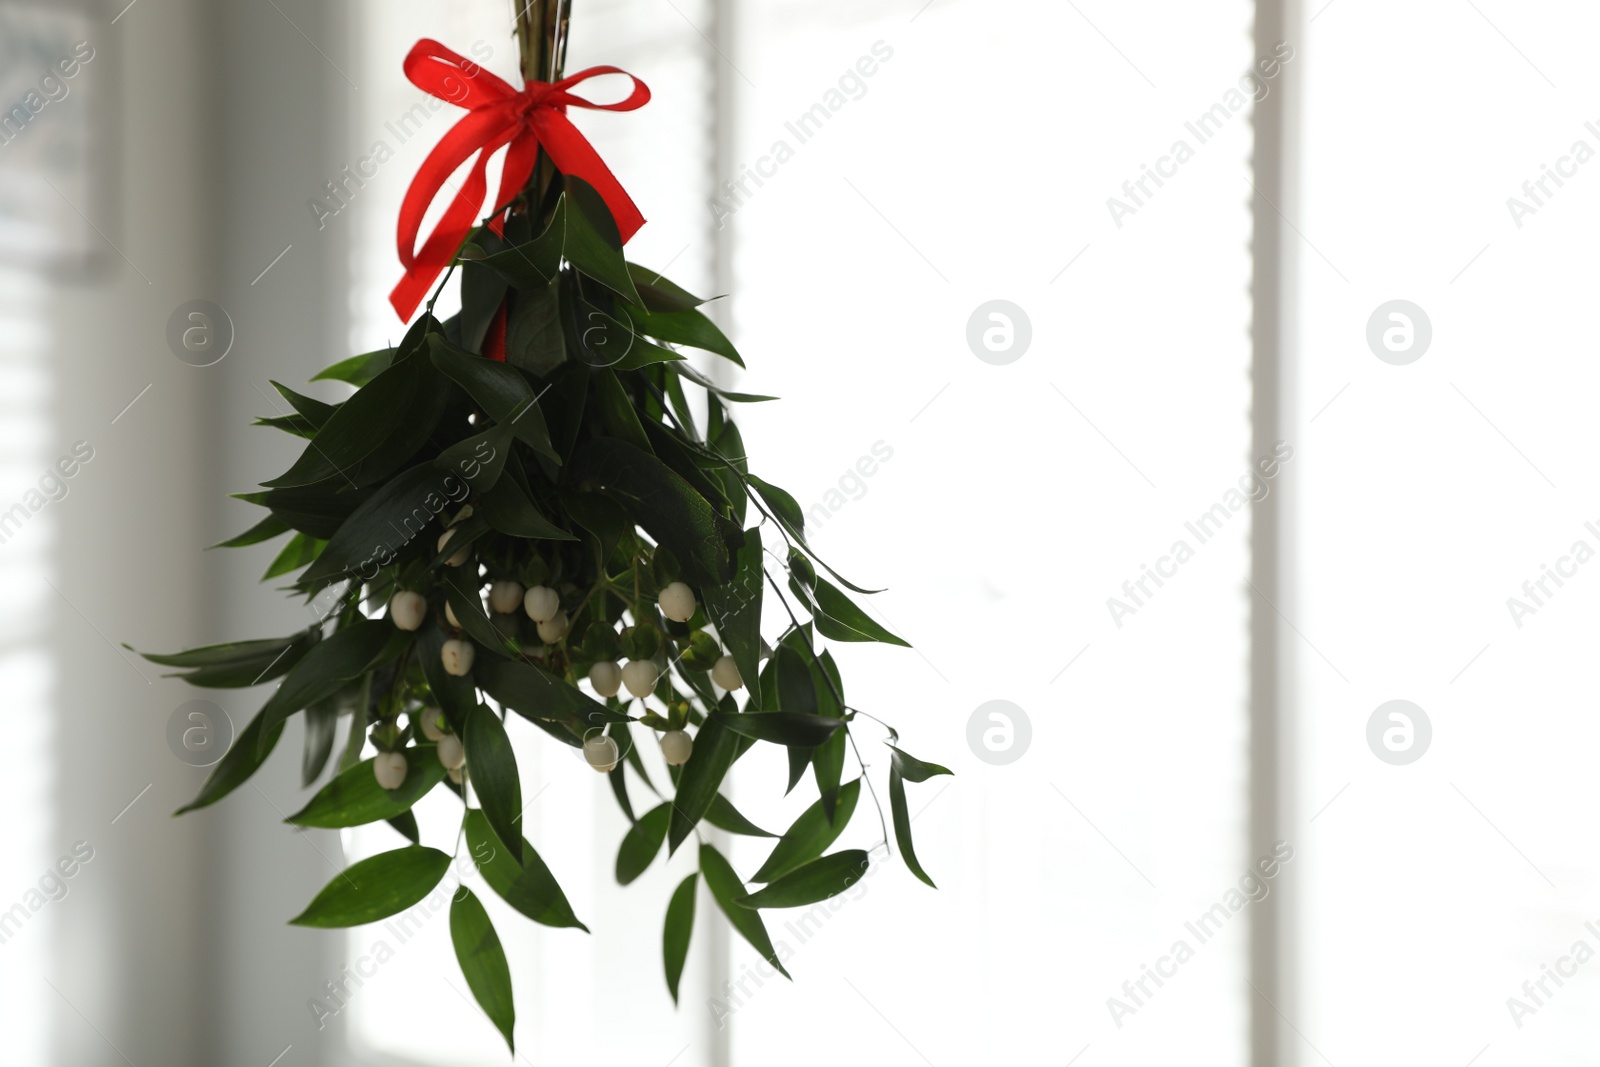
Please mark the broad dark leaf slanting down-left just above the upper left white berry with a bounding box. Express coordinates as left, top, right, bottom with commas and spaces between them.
299, 463, 464, 585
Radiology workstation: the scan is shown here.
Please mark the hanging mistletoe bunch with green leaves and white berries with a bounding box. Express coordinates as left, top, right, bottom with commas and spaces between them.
134, 6, 949, 1043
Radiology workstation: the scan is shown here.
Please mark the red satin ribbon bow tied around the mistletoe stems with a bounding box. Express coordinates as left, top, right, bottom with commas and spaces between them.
389, 38, 650, 320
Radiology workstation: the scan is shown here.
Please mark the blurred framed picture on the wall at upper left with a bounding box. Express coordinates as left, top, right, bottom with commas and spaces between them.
0, 0, 115, 275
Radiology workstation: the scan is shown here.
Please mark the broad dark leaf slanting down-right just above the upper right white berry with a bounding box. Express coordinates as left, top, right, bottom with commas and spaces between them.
568, 437, 744, 585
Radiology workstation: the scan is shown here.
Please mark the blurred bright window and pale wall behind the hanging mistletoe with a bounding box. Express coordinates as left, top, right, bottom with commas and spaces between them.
0, 0, 1600, 1067
